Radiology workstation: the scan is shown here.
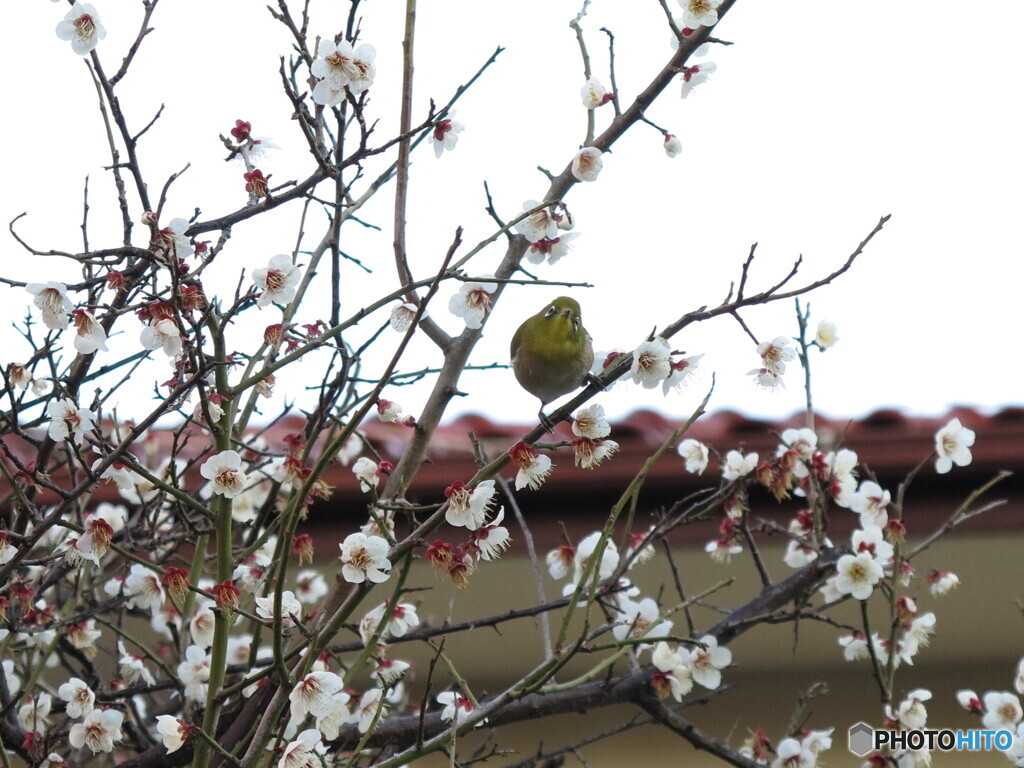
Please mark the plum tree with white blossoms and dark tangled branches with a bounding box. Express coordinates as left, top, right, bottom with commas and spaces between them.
0, 0, 1020, 768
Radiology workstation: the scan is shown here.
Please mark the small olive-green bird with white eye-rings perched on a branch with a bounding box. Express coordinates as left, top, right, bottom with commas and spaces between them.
512, 296, 594, 431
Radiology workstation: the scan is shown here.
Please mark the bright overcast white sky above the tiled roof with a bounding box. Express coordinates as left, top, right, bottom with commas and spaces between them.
0, 0, 1024, 428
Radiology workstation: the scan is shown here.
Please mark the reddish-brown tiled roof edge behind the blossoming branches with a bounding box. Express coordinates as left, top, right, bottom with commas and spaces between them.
0, 407, 1024, 544
